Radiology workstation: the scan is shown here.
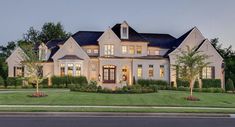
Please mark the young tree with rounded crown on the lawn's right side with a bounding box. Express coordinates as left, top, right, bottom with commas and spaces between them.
173, 46, 209, 97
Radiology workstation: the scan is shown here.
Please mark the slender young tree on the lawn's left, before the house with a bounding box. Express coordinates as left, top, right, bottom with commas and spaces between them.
20, 44, 43, 96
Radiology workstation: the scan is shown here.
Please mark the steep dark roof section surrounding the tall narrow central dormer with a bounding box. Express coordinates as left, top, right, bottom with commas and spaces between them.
112, 24, 148, 42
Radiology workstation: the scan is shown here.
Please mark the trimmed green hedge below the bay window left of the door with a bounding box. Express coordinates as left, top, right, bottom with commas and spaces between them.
51, 76, 88, 88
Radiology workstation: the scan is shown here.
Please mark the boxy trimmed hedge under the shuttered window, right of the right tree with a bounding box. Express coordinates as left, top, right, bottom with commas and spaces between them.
202, 79, 221, 88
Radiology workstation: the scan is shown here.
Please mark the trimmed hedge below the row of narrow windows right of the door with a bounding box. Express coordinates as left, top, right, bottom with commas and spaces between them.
137, 79, 169, 89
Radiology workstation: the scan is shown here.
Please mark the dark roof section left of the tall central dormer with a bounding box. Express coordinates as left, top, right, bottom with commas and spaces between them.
72, 31, 104, 46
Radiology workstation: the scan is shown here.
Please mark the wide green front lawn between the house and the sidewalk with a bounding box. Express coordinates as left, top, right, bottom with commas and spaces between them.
0, 90, 235, 108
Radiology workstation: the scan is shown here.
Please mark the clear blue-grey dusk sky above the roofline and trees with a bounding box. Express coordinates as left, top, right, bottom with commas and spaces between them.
0, 0, 235, 47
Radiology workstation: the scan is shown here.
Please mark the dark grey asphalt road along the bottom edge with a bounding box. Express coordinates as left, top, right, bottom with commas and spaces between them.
0, 116, 235, 127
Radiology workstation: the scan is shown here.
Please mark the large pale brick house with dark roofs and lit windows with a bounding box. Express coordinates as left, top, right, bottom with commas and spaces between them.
7, 21, 224, 88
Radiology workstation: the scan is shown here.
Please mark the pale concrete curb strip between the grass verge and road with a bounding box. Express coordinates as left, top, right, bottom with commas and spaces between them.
0, 112, 229, 118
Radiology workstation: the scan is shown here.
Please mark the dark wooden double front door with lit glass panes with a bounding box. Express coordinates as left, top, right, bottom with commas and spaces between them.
103, 65, 116, 83
